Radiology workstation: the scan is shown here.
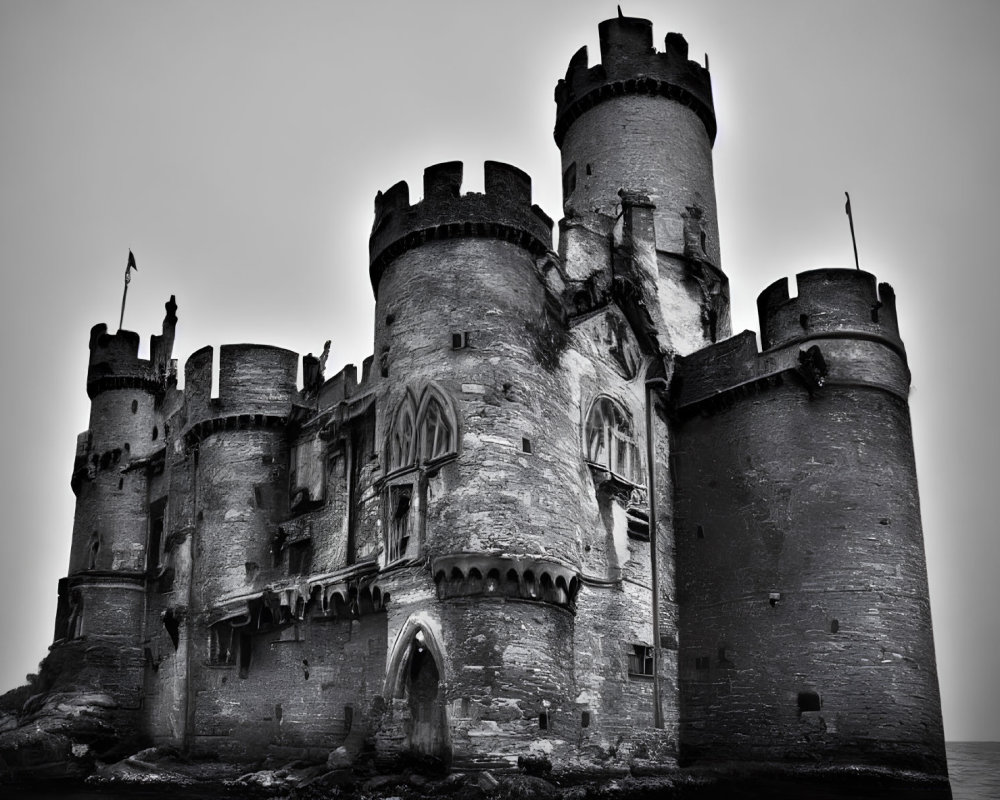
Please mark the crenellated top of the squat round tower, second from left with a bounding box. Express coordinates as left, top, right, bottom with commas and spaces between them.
184, 344, 298, 432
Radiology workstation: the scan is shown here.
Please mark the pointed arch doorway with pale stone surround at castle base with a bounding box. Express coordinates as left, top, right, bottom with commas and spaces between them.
385, 615, 451, 766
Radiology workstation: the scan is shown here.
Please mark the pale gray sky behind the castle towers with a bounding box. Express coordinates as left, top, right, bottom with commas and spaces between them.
0, 0, 1000, 740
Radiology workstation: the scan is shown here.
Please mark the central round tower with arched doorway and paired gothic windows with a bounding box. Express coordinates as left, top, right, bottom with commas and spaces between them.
370, 162, 581, 760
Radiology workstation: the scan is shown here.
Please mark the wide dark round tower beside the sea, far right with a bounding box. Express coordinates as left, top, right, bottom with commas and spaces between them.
674, 269, 945, 772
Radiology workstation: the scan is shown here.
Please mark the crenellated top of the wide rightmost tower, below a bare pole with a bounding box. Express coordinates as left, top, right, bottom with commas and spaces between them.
757, 269, 904, 355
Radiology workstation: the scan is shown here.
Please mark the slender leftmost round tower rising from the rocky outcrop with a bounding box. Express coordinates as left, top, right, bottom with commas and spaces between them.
55, 297, 177, 709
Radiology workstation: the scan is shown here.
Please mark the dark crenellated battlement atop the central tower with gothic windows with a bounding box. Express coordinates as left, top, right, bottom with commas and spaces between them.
368, 161, 552, 296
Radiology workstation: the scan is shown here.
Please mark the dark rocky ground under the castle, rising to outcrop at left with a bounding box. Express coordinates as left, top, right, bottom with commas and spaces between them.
0, 691, 951, 800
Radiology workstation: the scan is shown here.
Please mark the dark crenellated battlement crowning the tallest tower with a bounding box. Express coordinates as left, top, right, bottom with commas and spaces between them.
555, 17, 716, 147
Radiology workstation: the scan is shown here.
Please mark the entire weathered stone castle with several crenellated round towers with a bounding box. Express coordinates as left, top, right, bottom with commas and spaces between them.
53, 10, 945, 773
